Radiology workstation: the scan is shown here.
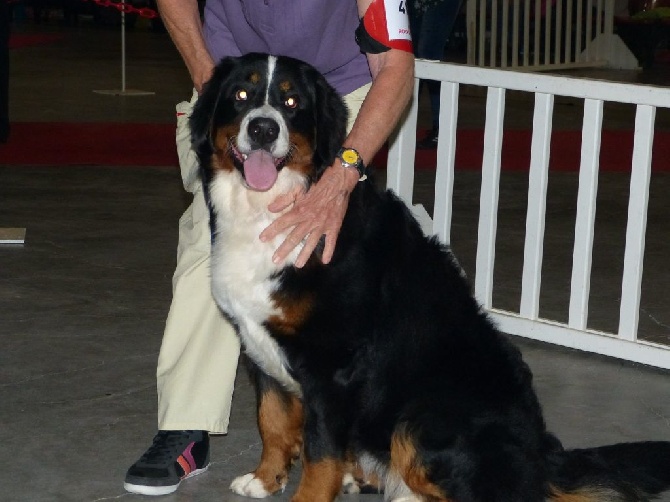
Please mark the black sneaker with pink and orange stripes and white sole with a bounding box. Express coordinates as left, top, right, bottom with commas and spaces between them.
123, 431, 209, 495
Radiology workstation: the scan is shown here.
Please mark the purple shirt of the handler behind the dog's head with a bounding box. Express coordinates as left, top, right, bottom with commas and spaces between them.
204, 0, 372, 95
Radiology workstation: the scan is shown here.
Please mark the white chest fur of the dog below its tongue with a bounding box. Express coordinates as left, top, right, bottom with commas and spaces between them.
210, 170, 301, 395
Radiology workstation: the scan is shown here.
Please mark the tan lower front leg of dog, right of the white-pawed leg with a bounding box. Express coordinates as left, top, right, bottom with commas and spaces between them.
291, 457, 345, 502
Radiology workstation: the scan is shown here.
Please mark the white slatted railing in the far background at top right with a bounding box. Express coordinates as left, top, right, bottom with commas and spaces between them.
466, 0, 637, 70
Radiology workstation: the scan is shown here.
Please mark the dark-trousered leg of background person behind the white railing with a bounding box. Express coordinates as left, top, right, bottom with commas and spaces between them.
414, 0, 462, 148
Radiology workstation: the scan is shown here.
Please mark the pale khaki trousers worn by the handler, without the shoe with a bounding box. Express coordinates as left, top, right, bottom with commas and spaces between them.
156, 84, 370, 434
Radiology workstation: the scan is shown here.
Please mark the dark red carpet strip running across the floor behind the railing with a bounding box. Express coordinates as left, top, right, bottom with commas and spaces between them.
0, 122, 670, 172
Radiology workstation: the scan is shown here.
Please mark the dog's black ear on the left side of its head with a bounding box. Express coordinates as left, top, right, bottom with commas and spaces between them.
189, 58, 235, 163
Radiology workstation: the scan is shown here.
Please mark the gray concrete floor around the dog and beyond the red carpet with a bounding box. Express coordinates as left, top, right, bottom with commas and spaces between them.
0, 10, 670, 502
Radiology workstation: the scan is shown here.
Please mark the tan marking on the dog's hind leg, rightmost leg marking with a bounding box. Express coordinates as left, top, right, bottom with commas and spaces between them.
391, 427, 451, 502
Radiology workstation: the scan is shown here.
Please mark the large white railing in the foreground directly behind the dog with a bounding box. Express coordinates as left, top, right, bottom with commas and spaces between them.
387, 60, 670, 369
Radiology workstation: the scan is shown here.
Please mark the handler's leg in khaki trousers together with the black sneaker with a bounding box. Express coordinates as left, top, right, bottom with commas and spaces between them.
124, 85, 369, 495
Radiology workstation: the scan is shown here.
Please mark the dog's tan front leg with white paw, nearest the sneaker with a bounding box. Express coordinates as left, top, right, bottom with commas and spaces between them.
230, 391, 303, 498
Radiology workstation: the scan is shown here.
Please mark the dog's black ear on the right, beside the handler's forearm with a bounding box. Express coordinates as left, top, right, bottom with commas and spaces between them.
314, 71, 349, 174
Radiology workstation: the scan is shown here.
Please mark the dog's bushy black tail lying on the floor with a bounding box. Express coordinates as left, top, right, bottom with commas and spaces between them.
550, 442, 670, 502
